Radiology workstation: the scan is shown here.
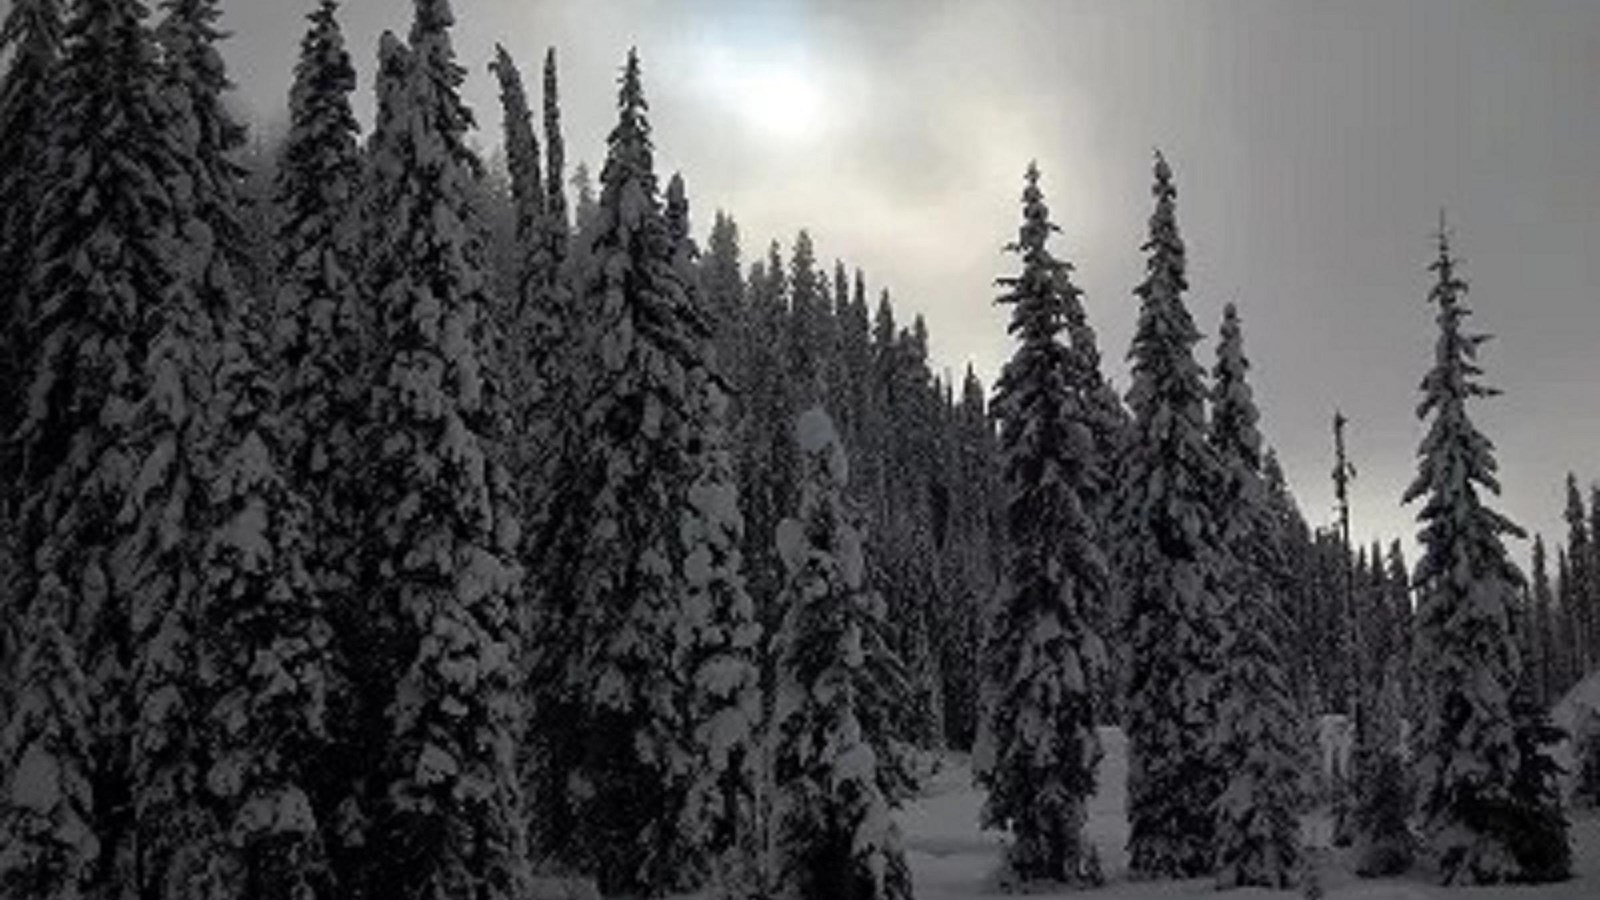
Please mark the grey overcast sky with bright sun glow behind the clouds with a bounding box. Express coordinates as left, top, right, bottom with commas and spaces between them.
128, 0, 1600, 557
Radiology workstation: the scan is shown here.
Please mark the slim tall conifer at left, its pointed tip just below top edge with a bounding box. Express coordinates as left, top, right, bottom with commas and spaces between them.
275, 2, 366, 890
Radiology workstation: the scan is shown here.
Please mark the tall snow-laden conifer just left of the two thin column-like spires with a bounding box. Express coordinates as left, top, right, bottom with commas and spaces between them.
362, 0, 523, 897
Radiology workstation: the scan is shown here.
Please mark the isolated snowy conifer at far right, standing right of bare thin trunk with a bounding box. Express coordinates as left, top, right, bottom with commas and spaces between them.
1405, 219, 1566, 884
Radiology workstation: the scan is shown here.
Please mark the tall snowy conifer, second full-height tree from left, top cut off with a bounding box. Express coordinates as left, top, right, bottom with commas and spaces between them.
125, 0, 262, 895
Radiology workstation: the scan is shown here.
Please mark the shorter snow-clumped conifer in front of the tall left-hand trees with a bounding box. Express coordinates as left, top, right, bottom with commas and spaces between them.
195, 272, 334, 900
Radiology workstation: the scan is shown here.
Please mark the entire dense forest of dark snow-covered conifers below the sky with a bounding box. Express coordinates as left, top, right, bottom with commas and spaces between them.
0, 0, 1600, 900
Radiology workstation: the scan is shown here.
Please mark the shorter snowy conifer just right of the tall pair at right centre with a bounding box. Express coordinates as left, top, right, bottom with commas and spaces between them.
1208, 303, 1301, 887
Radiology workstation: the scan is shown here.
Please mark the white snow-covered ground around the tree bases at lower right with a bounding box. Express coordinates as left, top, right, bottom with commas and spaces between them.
901, 729, 1600, 900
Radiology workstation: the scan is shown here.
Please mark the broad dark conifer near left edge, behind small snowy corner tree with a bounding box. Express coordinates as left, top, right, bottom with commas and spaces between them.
18, 0, 196, 894
